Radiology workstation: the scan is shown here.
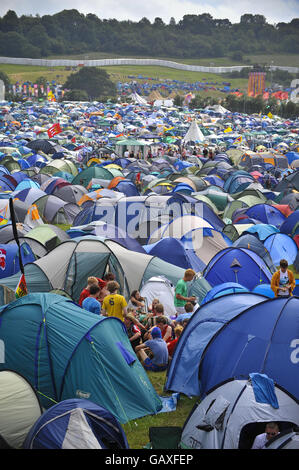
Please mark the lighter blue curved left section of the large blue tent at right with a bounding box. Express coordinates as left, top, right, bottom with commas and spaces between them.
164, 292, 268, 396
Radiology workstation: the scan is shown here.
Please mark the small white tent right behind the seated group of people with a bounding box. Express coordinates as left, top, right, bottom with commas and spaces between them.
140, 276, 176, 317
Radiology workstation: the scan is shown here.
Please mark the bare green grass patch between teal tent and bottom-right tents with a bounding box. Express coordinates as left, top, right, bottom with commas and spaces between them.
123, 371, 198, 449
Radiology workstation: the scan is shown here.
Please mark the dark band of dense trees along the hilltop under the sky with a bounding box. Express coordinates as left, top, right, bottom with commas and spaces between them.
0, 9, 299, 61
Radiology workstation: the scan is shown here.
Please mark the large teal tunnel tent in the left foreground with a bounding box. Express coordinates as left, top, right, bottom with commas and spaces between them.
0, 293, 162, 423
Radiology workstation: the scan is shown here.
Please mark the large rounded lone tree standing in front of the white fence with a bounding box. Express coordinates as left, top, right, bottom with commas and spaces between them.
64, 67, 116, 99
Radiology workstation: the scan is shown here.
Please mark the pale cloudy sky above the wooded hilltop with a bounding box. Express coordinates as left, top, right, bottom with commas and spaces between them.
0, 0, 299, 24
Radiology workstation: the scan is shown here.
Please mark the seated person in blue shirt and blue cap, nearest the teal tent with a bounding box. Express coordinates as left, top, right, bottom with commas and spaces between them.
135, 326, 168, 372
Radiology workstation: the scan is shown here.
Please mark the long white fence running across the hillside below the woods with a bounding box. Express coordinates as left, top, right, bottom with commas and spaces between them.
0, 57, 299, 73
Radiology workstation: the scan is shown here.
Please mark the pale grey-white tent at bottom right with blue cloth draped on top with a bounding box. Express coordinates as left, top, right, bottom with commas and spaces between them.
180, 373, 299, 449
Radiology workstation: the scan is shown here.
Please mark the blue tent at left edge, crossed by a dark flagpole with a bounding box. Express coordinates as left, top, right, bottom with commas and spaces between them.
0, 243, 35, 279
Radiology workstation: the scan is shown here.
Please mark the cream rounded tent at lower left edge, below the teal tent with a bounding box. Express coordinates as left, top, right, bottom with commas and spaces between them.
0, 370, 42, 449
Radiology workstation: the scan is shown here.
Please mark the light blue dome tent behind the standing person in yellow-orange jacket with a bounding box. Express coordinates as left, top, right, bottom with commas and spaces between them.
264, 233, 298, 266
